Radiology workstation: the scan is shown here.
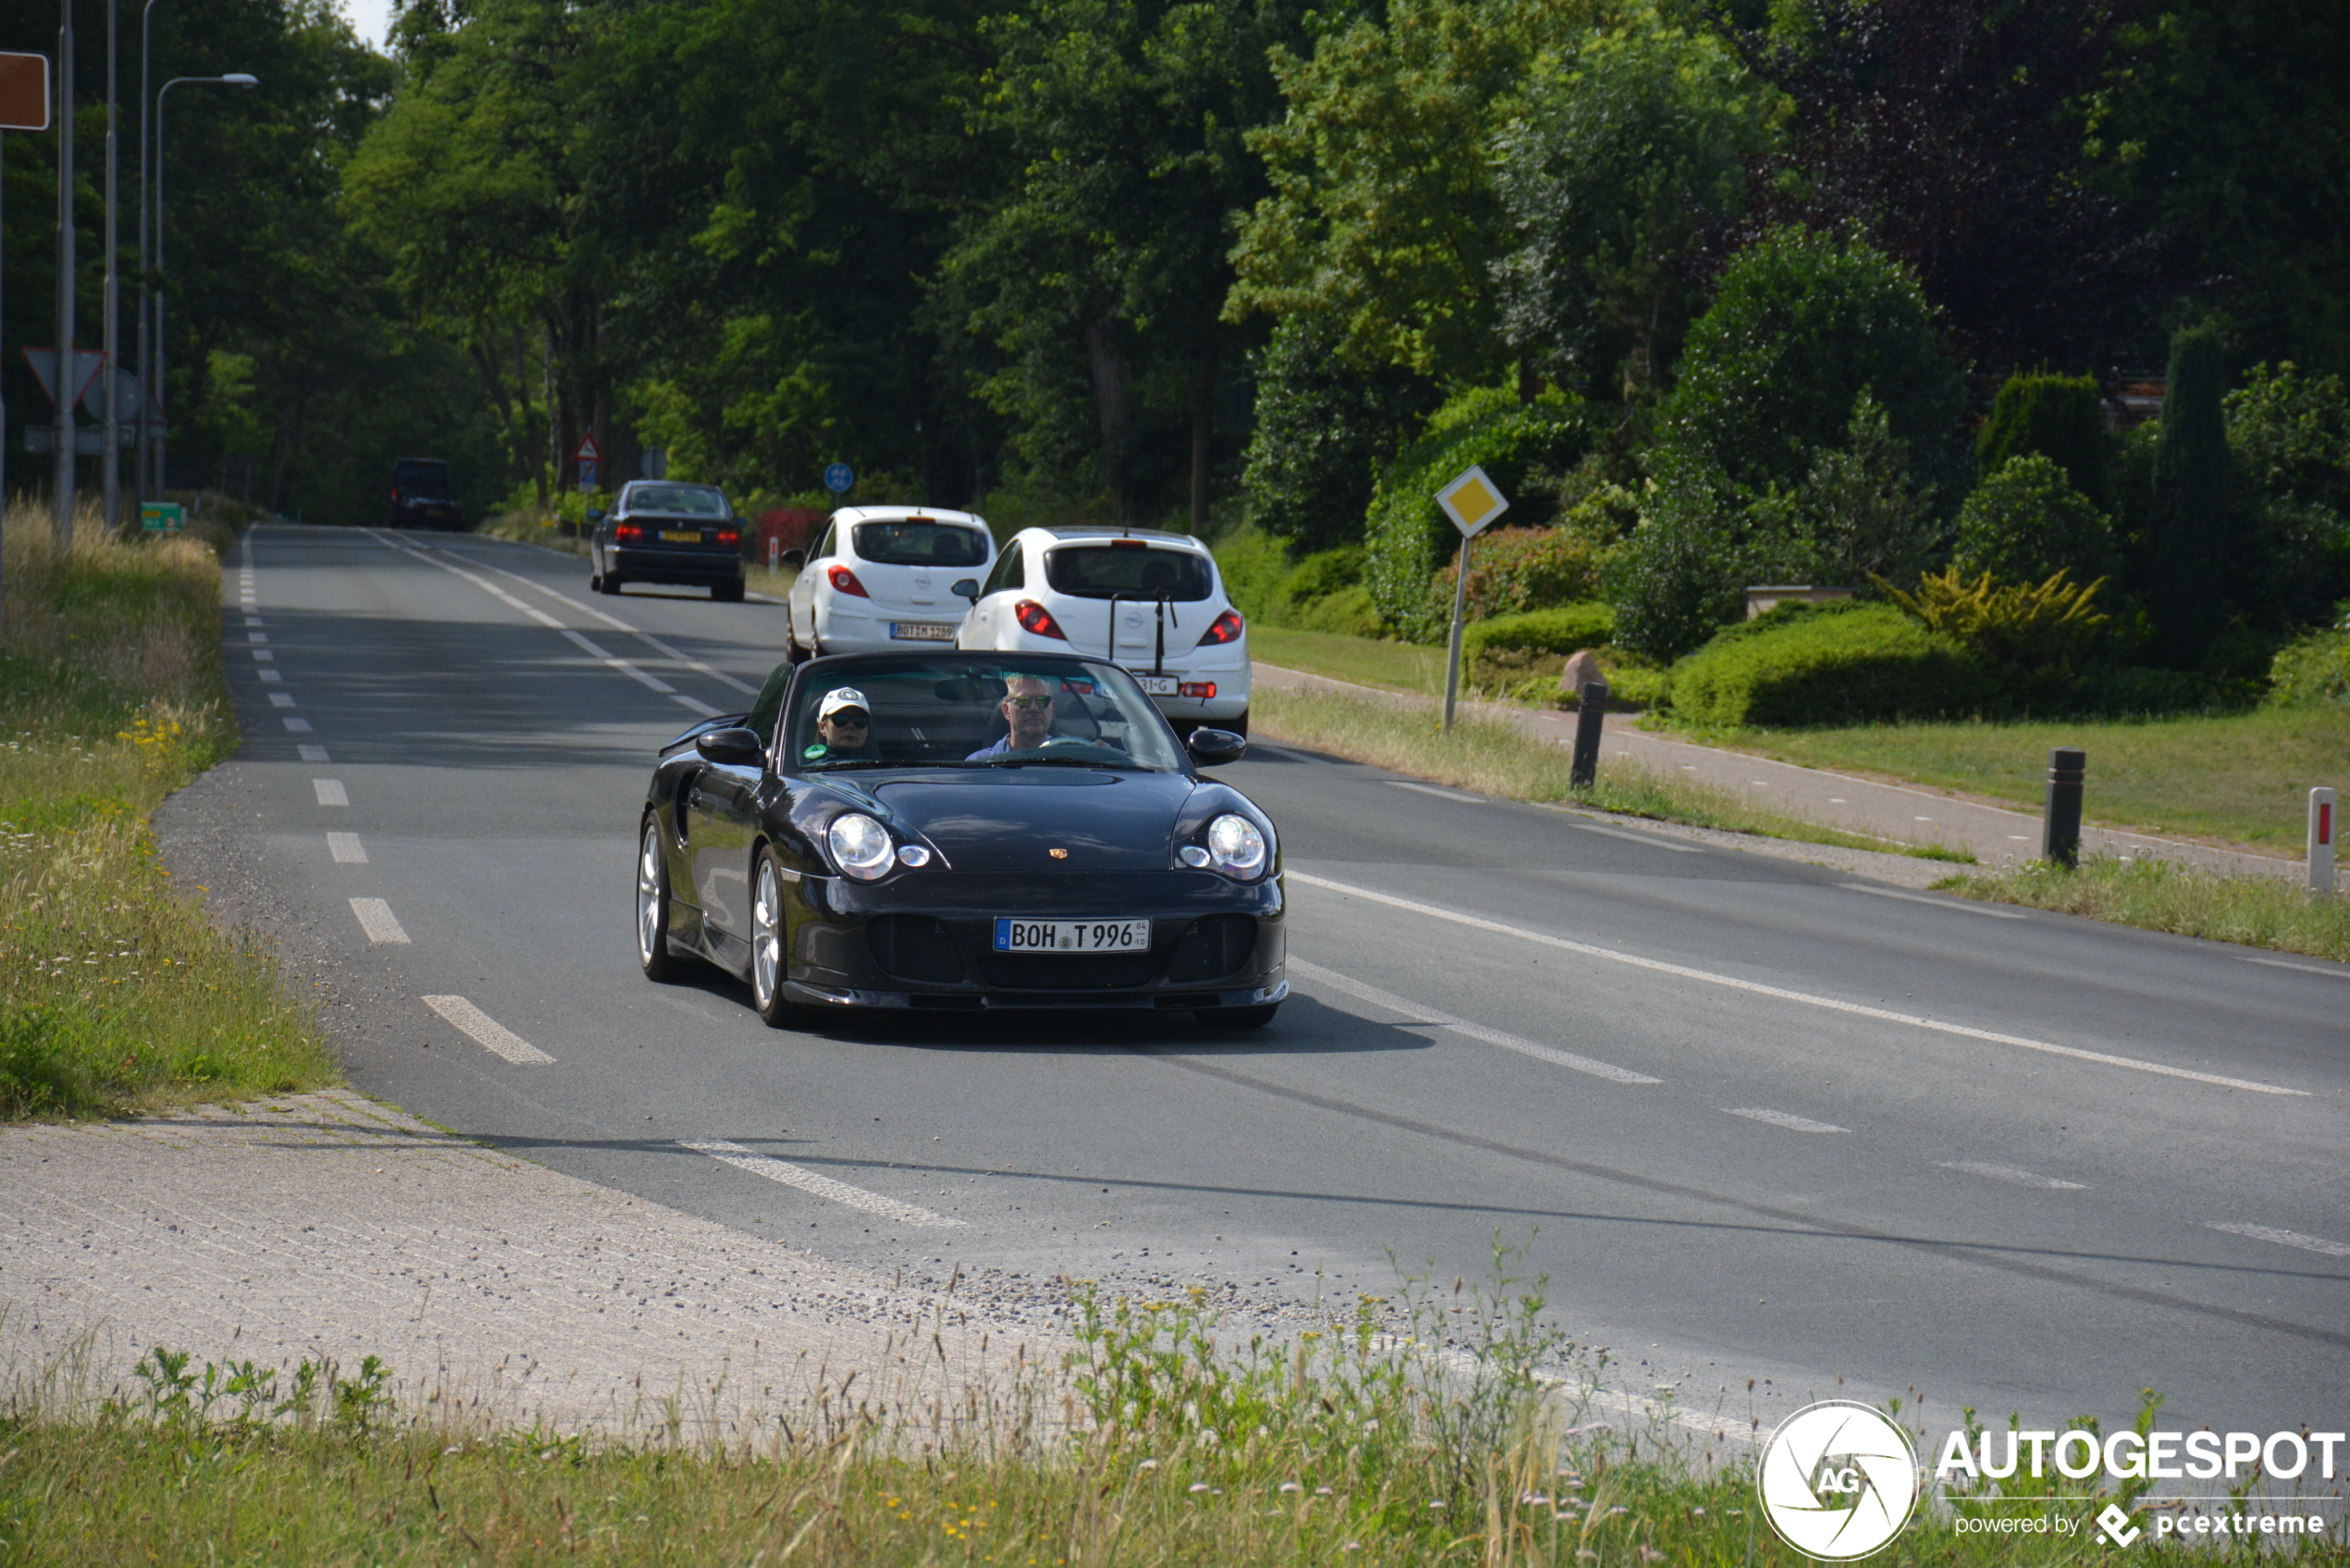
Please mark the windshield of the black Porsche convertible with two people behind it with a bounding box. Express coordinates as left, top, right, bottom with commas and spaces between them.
783, 653, 1184, 773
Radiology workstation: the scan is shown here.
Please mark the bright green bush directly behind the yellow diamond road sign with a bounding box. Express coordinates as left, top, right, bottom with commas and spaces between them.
1363, 388, 1596, 642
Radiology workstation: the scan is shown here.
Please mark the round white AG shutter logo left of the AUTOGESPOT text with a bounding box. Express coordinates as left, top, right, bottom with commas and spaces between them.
1755, 1399, 1918, 1563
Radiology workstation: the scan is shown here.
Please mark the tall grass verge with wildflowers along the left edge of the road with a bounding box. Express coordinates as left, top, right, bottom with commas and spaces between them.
0, 505, 334, 1117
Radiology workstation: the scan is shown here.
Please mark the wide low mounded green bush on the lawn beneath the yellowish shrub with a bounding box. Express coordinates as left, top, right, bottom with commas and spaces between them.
1673, 604, 1998, 726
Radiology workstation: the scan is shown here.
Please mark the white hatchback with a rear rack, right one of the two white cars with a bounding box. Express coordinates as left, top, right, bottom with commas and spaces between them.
957, 529, 1248, 735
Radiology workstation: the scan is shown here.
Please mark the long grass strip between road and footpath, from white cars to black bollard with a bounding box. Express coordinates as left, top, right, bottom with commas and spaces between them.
1248, 686, 1974, 863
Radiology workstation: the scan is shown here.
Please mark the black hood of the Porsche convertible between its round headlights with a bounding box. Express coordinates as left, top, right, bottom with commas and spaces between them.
865, 766, 1198, 872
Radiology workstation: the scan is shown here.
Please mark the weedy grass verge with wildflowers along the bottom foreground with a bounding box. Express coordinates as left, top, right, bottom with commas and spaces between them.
0, 1281, 2283, 1568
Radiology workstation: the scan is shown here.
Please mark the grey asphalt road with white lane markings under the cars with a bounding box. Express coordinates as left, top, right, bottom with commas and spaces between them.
191, 526, 2350, 1457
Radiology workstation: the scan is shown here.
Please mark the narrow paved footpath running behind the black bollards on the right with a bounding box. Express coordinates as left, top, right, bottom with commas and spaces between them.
1250, 663, 2307, 879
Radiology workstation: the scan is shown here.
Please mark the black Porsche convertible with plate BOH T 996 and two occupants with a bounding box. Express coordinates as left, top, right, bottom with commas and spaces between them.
637, 651, 1290, 1028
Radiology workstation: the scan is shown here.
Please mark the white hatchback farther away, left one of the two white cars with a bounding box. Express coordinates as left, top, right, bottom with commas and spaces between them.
783, 505, 996, 661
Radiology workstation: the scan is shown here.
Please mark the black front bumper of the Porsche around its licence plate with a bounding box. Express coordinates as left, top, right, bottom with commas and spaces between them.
787, 870, 1288, 1011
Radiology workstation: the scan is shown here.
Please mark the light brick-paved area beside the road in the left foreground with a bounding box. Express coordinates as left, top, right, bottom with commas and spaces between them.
0, 1091, 1060, 1434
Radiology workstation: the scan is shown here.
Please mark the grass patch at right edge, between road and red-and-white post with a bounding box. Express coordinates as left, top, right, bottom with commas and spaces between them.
1936, 856, 2350, 964
